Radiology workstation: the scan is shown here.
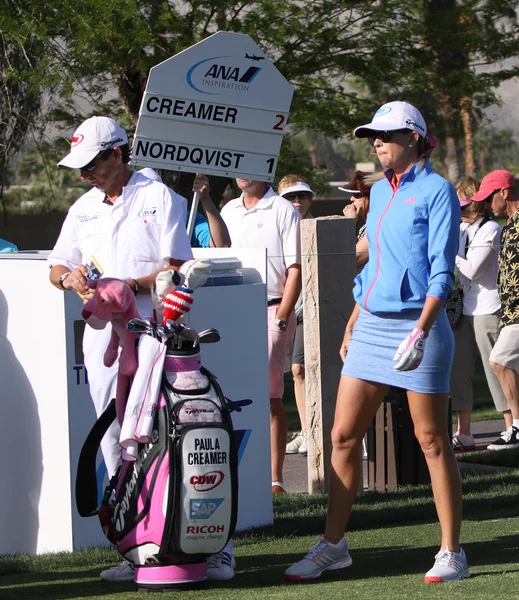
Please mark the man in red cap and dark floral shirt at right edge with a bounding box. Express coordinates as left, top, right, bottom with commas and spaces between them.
472, 170, 519, 450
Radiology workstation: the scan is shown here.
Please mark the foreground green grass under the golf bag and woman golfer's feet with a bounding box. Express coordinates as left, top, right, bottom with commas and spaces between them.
0, 472, 519, 600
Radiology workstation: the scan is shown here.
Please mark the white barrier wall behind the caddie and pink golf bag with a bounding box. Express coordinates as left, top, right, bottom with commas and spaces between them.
0, 249, 272, 554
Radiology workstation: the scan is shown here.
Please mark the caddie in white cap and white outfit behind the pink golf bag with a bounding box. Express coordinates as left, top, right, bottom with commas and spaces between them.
48, 117, 234, 581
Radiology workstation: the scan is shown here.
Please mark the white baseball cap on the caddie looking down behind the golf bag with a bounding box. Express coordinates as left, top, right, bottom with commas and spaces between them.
58, 117, 128, 169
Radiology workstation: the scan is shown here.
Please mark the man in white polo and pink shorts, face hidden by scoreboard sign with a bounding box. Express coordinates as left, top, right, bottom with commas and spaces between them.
221, 178, 301, 494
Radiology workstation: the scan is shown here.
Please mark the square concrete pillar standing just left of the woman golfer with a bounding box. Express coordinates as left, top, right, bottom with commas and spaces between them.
301, 216, 356, 494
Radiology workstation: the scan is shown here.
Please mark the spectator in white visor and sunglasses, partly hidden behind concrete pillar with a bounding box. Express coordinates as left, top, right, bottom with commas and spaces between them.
278, 175, 315, 456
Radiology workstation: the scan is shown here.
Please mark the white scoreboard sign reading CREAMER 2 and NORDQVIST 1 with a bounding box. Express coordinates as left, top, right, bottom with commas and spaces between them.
132, 32, 293, 182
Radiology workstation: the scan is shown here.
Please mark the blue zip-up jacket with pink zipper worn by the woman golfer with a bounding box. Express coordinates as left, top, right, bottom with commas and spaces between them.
353, 159, 460, 314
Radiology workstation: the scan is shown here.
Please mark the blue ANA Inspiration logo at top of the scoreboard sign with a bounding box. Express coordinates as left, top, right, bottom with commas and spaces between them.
186, 56, 262, 96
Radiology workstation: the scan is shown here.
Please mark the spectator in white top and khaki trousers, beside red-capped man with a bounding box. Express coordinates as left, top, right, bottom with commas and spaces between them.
451, 177, 511, 452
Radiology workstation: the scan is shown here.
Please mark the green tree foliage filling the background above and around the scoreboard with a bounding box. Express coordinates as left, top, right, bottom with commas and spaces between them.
0, 0, 519, 197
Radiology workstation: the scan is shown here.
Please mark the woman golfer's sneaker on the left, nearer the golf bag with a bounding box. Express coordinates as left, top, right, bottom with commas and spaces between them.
285, 538, 352, 581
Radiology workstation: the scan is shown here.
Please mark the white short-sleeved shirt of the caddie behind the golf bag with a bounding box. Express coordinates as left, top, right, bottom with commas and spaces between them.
48, 172, 193, 278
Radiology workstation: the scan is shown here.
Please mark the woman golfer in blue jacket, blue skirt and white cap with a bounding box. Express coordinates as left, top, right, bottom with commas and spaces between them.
285, 102, 469, 583
